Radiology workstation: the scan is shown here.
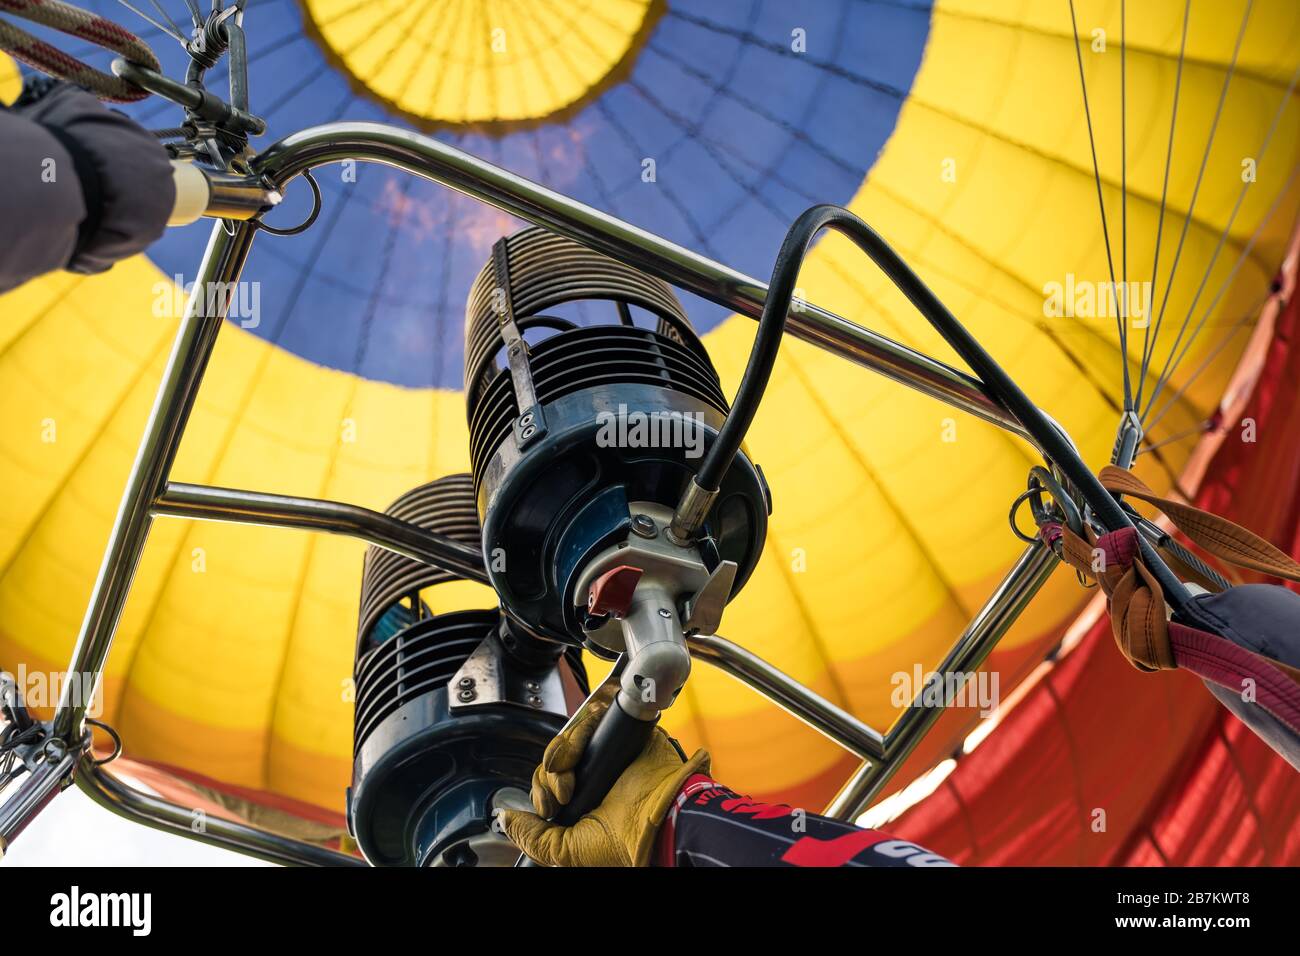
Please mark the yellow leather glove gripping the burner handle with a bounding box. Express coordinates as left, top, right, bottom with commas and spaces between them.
501, 698, 709, 866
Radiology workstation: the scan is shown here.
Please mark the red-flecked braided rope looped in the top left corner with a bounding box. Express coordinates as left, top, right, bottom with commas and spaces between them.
0, 0, 161, 103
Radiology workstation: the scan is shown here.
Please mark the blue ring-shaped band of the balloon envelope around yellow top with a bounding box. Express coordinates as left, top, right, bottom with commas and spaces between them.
71, 0, 930, 389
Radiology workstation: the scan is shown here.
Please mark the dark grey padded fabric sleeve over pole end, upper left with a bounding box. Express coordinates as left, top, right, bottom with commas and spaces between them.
0, 77, 176, 293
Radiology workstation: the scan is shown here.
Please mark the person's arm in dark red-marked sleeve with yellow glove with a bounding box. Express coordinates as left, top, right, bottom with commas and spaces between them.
501, 700, 952, 866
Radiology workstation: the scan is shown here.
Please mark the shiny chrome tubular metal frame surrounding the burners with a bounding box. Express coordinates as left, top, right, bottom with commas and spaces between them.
0, 122, 1076, 865
